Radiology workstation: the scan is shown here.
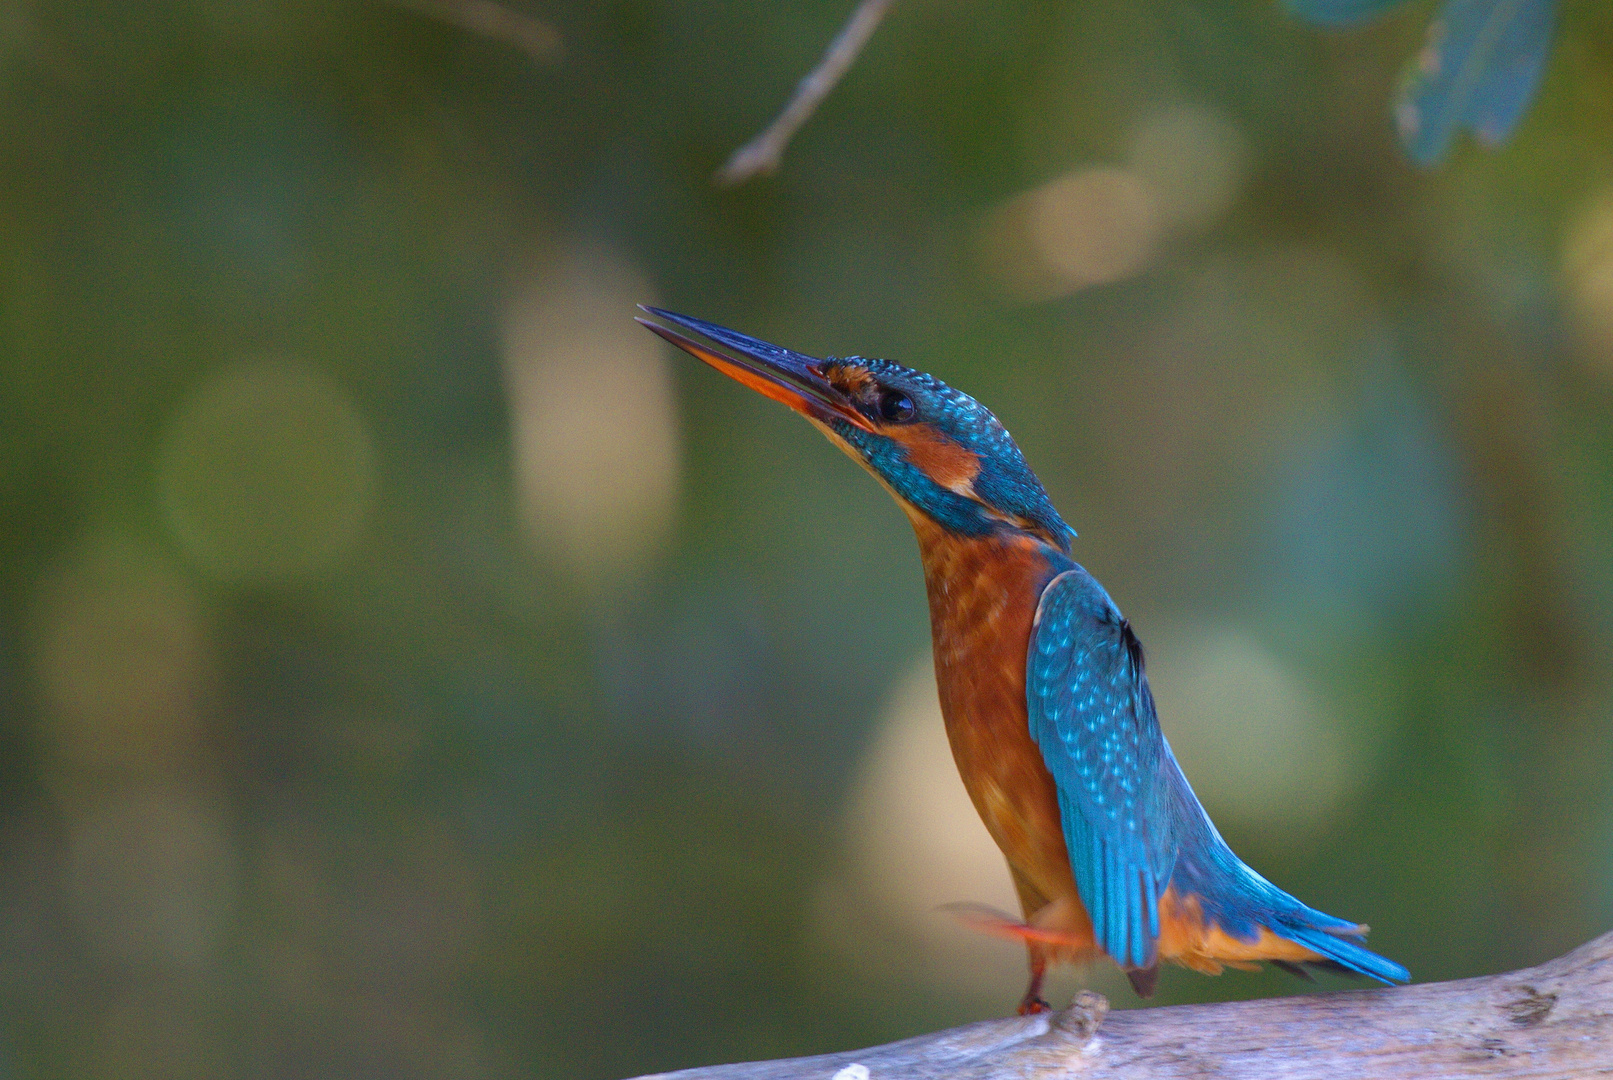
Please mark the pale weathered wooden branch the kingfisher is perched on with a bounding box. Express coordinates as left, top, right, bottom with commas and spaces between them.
644, 933, 1613, 1080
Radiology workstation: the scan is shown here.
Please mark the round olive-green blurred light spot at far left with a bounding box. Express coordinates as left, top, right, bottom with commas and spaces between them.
158, 359, 376, 584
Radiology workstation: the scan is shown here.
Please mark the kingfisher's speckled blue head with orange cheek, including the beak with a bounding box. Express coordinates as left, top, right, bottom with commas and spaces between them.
639, 308, 1076, 553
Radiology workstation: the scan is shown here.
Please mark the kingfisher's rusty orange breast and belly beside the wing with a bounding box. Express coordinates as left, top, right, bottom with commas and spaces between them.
911, 514, 1092, 959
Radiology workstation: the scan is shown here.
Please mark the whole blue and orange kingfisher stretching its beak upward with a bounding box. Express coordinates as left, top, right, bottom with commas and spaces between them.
639, 308, 1410, 1014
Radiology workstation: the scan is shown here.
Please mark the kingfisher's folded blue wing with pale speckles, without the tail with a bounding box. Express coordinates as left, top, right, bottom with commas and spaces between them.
1026, 566, 1176, 969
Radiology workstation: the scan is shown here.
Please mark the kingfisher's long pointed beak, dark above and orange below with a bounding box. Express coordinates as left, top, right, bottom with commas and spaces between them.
639, 305, 873, 432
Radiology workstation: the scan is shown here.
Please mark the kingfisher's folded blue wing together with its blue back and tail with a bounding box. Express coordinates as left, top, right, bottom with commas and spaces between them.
1026, 566, 1408, 995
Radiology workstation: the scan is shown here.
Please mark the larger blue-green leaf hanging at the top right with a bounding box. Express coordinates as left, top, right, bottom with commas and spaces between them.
1395, 0, 1557, 166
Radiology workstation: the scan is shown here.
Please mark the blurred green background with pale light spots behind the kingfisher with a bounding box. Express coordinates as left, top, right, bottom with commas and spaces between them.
9, 0, 1613, 1078
